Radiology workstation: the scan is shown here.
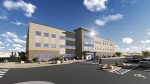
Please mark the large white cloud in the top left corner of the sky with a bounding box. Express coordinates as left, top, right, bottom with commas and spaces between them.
3, 0, 36, 18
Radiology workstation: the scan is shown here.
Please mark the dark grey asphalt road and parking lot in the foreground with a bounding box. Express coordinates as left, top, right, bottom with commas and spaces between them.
0, 60, 150, 84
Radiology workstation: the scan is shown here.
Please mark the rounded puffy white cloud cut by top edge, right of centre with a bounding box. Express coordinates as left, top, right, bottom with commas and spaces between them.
83, 0, 108, 12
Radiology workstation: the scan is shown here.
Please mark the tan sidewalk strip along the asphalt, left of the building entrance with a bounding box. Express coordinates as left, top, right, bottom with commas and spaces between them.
0, 60, 81, 68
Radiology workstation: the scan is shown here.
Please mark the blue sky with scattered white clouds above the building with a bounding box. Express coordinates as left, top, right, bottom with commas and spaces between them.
0, 0, 150, 52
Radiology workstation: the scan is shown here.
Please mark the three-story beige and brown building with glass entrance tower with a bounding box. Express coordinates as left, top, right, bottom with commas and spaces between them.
26, 23, 114, 60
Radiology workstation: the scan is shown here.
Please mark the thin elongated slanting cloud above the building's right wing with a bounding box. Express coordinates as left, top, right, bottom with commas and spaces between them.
95, 14, 123, 26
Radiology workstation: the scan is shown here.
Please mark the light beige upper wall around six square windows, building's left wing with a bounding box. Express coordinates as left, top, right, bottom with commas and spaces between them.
28, 23, 60, 51
